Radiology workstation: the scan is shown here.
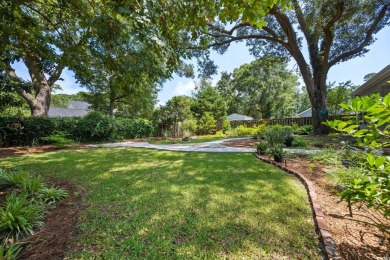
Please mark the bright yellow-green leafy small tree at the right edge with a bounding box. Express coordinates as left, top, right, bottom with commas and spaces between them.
325, 94, 390, 222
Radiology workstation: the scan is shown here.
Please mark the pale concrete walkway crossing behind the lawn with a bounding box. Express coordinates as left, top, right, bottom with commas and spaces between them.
88, 138, 319, 154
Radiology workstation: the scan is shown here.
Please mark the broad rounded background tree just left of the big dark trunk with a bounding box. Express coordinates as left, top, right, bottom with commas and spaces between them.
232, 57, 298, 118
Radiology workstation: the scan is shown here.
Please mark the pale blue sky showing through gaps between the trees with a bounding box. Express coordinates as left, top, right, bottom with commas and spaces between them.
15, 26, 390, 105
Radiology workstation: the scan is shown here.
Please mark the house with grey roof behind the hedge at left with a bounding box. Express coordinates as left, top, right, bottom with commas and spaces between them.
47, 100, 91, 117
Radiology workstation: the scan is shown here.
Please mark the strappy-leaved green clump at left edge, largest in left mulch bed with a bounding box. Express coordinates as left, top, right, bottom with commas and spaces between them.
0, 193, 45, 241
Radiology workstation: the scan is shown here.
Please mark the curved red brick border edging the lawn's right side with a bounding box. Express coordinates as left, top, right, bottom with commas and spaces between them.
254, 153, 341, 260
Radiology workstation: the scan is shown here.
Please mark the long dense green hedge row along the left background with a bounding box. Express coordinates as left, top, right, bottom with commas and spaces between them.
0, 112, 154, 147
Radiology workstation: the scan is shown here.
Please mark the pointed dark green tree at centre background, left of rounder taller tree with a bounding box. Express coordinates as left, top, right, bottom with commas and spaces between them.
191, 83, 226, 122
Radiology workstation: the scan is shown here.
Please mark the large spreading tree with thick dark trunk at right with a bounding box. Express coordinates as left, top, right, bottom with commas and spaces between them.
198, 0, 390, 134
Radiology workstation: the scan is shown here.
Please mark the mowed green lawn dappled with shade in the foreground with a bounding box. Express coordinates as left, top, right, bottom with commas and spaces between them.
0, 148, 321, 259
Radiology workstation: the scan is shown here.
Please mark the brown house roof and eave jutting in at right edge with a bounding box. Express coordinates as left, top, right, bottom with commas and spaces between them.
352, 65, 390, 97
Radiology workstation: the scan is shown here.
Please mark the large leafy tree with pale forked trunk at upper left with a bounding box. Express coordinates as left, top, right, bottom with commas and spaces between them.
0, 0, 187, 116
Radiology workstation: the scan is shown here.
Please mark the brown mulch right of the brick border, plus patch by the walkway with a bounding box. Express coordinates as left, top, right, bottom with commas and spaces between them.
223, 140, 390, 260
